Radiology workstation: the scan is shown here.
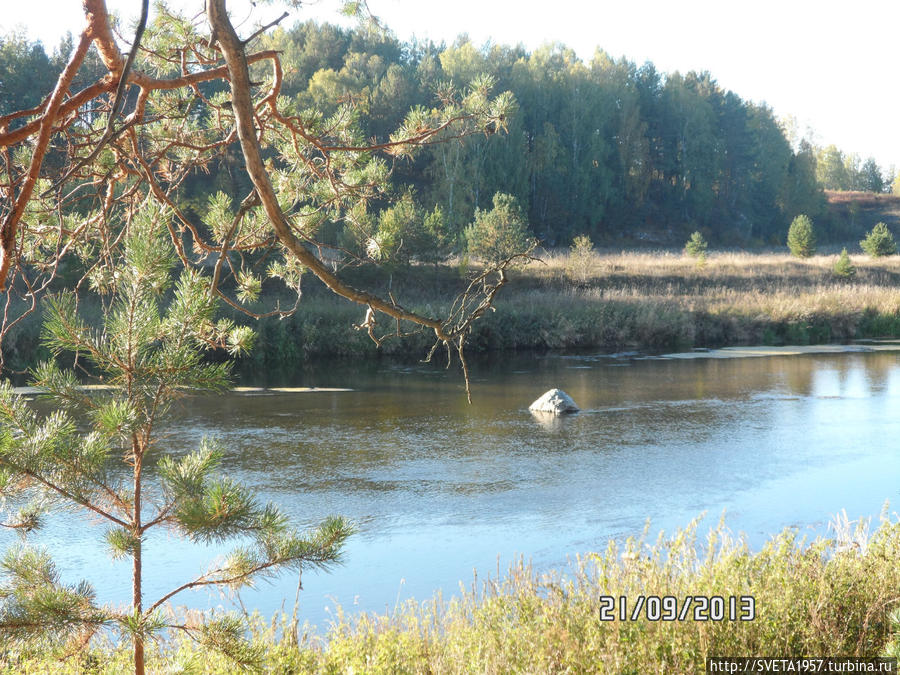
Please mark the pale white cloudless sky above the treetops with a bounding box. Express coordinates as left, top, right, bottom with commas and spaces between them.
7, 0, 900, 170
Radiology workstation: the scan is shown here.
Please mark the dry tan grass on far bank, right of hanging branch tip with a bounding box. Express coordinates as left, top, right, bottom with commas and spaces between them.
442, 252, 900, 350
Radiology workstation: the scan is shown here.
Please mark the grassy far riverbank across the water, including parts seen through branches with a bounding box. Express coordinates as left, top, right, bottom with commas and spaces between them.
4, 252, 900, 374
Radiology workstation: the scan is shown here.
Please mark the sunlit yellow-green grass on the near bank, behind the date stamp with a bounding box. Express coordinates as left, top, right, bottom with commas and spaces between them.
0, 517, 900, 674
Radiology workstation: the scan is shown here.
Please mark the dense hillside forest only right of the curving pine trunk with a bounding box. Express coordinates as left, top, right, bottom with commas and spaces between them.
256, 24, 825, 244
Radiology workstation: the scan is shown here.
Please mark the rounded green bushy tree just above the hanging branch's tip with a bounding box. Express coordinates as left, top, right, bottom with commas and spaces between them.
465, 192, 529, 263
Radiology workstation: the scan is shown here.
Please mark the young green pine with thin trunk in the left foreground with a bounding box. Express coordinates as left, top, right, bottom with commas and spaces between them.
0, 208, 350, 673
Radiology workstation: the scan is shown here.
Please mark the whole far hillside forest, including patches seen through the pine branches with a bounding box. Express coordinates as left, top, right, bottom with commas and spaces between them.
0, 22, 893, 259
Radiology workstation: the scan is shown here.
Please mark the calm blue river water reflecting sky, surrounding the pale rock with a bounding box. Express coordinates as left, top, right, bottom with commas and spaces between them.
7, 352, 900, 627
